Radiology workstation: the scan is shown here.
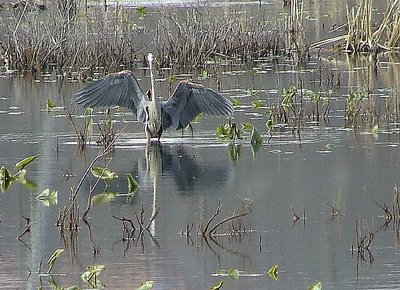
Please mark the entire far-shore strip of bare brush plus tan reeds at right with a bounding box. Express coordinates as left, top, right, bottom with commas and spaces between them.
0, 0, 400, 74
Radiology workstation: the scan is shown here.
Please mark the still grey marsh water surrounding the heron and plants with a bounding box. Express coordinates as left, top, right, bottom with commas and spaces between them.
0, 1, 400, 289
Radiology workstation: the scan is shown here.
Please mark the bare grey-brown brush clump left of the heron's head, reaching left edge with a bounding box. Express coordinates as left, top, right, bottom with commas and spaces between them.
0, 0, 148, 72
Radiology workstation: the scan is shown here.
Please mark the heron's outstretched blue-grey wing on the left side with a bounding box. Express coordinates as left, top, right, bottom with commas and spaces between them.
75, 70, 148, 122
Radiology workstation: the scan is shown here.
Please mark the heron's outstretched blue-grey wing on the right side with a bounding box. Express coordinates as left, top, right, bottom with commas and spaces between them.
161, 81, 233, 130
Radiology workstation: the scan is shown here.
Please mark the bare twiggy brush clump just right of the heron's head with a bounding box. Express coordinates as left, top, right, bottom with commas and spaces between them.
155, 6, 284, 67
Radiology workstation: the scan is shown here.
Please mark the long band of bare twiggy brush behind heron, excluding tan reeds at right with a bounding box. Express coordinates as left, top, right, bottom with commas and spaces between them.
0, 0, 284, 73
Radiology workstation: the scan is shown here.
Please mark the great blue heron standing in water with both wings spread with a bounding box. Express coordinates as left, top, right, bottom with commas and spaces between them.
75, 53, 233, 142
